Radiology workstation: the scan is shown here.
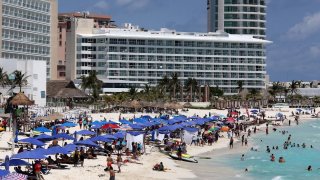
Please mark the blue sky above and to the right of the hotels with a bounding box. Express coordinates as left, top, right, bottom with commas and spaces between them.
59, 0, 320, 81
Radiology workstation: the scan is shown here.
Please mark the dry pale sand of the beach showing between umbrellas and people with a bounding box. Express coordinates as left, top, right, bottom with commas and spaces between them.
0, 108, 319, 180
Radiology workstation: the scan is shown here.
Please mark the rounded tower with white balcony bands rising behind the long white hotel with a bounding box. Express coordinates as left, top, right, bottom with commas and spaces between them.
207, 0, 267, 39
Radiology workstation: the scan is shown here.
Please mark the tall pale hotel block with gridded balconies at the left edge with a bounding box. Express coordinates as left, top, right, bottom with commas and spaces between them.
0, 0, 58, 79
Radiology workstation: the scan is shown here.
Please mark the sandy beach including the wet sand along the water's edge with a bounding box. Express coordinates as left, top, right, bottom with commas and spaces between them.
0, 109, 317, 180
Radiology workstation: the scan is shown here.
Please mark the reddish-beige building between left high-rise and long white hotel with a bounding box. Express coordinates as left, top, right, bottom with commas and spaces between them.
56, 12, 116, 80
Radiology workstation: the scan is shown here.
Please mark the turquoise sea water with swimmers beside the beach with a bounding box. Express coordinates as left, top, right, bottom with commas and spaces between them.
180, 120, 320, 180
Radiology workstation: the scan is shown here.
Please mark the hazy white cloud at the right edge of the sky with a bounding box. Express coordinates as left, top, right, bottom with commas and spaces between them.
287, 12, 320, 40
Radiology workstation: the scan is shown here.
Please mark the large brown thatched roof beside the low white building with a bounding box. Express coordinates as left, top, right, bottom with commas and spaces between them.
47, 80, 90, 99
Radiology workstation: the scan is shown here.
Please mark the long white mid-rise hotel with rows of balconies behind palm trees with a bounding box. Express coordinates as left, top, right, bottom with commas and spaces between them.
67, 24, 270, 94
